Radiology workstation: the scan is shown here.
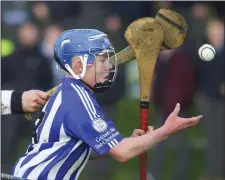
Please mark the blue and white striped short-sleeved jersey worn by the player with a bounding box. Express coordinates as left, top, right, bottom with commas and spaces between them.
12, 78, 123, 180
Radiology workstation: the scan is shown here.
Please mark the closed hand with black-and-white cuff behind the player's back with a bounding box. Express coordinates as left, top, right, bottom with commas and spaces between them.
22, 90, 49, 112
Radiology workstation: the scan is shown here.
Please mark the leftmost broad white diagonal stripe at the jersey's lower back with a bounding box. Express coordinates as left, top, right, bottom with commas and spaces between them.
15, 142, 66, 177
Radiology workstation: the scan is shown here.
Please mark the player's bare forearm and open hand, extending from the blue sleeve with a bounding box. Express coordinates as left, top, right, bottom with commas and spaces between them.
109, 104, 202, 162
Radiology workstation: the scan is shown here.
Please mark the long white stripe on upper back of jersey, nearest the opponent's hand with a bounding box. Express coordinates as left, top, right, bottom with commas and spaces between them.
39, 91, 62, 142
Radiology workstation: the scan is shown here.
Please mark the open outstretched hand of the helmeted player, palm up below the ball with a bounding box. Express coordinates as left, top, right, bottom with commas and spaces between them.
163, 103, 203, 136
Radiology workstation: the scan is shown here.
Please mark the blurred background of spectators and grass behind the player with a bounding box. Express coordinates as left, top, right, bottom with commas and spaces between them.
1, 1, 225, 180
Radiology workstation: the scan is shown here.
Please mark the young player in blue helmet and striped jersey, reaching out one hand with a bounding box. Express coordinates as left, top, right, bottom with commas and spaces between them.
12, 29, 202, 180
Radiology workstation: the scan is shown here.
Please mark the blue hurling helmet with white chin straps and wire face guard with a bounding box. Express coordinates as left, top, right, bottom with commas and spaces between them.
54, 29, 117, 92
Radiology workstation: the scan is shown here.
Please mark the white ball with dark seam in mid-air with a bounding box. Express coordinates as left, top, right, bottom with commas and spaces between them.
198, 44, 216, 62
